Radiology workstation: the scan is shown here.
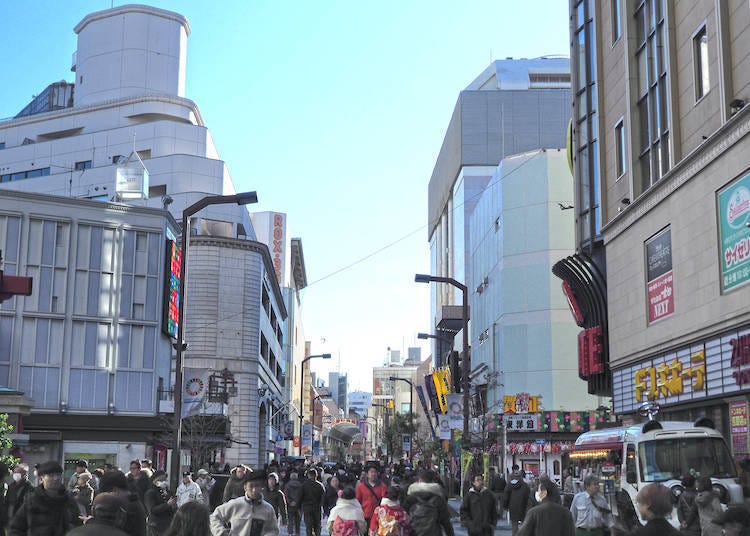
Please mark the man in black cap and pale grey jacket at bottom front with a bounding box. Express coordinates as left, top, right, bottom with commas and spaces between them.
210, 471, 279, 536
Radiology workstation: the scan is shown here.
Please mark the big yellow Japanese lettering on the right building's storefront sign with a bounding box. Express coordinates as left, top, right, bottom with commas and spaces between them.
633, 350, 706, 402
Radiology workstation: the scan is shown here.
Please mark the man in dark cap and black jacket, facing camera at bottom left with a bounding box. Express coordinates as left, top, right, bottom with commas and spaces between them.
8, 460, 81, 536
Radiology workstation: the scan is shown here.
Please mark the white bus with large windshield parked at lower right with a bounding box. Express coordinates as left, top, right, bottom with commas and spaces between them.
570, 409, 743, 530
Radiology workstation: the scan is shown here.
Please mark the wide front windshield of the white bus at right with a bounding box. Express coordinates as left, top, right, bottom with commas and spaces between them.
638, 437, 736, 482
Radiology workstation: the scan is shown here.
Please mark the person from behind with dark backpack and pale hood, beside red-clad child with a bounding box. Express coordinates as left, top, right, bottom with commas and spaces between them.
403, 469, 455, 536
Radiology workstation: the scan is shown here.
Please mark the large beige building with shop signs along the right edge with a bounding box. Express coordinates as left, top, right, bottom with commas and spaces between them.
568, 0, 750, 458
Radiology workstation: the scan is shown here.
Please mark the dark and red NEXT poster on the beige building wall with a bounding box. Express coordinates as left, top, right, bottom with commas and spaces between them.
646, 227, 674, 323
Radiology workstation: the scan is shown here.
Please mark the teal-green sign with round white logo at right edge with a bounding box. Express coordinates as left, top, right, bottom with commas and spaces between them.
717, 174, 750, 292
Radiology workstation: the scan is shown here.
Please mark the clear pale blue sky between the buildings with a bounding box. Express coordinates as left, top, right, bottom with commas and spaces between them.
0, 0, 569, 390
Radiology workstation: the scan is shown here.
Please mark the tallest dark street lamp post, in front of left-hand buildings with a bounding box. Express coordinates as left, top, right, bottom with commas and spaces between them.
169, 192, 258, 490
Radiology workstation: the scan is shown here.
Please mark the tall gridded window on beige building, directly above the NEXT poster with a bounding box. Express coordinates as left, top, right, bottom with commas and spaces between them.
633, 0, 671, 195
